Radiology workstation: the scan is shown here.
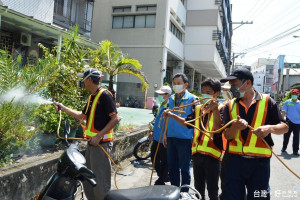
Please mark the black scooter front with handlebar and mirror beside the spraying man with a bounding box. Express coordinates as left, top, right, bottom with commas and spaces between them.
35, 121, 97, 200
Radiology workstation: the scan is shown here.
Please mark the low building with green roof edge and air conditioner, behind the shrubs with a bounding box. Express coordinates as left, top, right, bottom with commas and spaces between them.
0, 0, 97, 64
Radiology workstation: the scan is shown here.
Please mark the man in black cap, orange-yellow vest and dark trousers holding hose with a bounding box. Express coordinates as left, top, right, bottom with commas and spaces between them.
221, 69, 288, 200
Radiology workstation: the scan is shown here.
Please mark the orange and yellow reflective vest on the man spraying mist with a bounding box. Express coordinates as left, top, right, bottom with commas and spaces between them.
82, 89, 114, 142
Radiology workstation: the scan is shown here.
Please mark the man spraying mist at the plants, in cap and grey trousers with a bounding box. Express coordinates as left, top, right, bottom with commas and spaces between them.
57, 68, 120, 200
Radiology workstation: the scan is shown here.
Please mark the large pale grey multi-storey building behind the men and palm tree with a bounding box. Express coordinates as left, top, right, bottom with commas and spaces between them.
91, 0, 232, 104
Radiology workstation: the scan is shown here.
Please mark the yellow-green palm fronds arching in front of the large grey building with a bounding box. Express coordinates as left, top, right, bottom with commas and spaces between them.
91, 40, 149, 92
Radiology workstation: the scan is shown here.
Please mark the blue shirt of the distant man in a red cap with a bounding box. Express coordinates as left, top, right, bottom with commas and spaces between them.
282, 99, 300, 124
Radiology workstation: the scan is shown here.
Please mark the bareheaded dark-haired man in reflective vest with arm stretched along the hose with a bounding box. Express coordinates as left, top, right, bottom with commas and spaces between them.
164, 78, 226, 200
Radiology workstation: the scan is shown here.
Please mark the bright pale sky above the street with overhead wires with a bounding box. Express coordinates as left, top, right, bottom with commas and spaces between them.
231, 0, 300, 65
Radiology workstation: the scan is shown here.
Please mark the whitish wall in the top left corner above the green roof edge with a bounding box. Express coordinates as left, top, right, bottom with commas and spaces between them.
2, 0, 54, 23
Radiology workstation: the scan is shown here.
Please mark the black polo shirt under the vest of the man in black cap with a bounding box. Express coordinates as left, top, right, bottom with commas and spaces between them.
222, 91, 285, 146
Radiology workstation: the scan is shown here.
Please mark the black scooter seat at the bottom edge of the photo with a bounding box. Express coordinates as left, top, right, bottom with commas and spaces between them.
105, 185, 180, 200
